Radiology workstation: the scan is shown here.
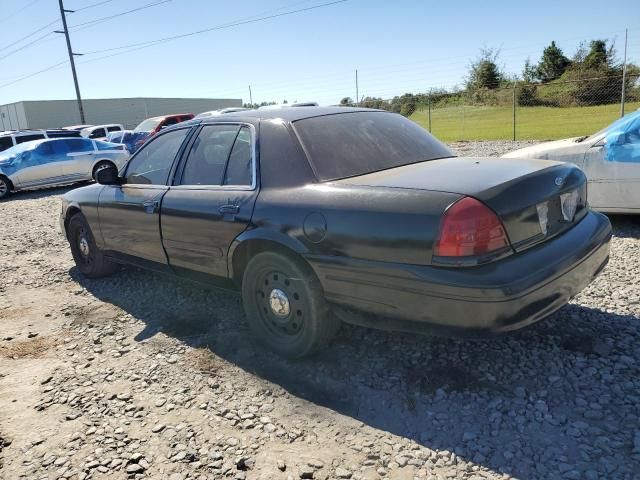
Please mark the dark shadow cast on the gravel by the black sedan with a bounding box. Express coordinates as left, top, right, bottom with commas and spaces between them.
70, 255, 639, 478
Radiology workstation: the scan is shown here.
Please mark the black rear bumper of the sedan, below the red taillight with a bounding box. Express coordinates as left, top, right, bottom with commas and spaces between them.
307, 212, 611, 336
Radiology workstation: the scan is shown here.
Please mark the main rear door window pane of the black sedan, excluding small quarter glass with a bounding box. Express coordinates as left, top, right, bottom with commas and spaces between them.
180, 125, 240, 185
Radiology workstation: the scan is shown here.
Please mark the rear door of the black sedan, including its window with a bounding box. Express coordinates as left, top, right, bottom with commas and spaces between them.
161, 123, 258, 277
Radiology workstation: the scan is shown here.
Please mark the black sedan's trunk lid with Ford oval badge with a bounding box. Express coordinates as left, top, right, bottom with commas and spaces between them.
335, 157, 586, 251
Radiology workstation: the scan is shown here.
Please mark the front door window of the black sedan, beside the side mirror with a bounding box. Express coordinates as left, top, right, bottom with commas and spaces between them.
125, 128, 189, 185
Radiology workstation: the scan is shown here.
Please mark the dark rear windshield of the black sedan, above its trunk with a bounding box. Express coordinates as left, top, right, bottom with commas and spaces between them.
293, 111, 455, 182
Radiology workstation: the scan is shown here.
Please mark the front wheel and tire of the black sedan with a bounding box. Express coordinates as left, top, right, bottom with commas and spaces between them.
67, 213, 118, 278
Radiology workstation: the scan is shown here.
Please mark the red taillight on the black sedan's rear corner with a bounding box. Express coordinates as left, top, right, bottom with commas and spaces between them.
433, 197, 509, 257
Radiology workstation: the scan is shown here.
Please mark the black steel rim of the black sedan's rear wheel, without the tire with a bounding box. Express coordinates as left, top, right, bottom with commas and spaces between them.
255, 269, 305, 340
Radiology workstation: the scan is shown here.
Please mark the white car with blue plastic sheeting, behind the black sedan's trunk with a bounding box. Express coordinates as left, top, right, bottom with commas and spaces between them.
504, 110, 640, 214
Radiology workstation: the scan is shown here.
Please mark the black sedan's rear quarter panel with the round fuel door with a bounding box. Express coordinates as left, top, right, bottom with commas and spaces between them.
253, 184, 460, 265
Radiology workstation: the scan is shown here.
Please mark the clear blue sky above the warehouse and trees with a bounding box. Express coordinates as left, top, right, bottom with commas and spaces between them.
0, 0, 640, 104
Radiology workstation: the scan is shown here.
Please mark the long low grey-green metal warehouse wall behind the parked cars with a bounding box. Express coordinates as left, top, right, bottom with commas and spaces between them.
0, 98, 242, 130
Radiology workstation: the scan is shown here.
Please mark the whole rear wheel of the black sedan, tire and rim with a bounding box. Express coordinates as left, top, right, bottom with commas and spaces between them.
242, 252, 340, 359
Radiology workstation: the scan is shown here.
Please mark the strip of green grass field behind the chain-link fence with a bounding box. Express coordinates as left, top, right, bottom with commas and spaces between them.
411, 102, 640, 142
